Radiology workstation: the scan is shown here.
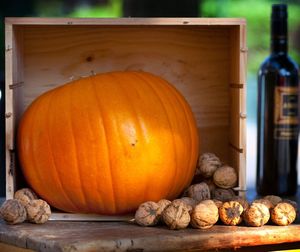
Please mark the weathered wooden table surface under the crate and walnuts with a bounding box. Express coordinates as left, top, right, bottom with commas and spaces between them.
0, 188, 300, 252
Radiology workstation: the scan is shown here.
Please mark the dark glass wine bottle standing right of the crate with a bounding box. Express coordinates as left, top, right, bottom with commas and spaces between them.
256, 4, 299, 196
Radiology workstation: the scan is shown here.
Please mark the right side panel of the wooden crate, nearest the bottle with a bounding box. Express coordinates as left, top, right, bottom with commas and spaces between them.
229, 26, 247, 190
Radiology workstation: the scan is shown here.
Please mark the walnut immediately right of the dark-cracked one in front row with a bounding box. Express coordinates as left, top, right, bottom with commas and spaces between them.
243, 203, 270, 227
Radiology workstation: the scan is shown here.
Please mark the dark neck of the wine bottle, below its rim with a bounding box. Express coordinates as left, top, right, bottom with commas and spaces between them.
271, 18, 288, 55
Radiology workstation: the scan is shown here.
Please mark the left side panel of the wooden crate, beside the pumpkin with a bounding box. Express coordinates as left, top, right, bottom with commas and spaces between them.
5, 24, 24, 198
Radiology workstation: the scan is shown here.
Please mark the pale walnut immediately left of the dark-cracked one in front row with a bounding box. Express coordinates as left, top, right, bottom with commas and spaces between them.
191, 200, 219, 229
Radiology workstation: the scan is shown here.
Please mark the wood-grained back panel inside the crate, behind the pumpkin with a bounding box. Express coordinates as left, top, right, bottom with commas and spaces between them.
22, 26, 230, 159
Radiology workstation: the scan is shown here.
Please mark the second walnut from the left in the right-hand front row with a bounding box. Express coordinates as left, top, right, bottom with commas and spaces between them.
162, 201, 191, 229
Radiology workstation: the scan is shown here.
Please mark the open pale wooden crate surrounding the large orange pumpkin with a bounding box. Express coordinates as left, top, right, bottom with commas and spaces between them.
5, 18, 247, 218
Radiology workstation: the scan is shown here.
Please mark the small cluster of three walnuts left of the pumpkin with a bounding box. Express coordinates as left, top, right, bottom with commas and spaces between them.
0, 188, 51, 225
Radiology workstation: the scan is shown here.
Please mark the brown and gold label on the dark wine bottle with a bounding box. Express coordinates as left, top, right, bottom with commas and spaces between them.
274, 87, 298, 139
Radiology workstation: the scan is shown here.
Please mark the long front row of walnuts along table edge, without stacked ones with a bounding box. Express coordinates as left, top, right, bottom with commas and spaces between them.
135, 192, 297, 229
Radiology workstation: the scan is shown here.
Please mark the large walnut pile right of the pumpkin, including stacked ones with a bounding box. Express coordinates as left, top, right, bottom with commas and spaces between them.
135, 153, 297, 229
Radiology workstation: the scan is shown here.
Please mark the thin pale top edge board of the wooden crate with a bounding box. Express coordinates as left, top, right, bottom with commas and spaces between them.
5, 17, 246, 26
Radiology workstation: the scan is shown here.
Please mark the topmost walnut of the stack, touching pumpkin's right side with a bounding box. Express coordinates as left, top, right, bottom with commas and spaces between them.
196, 153, 221, 178
